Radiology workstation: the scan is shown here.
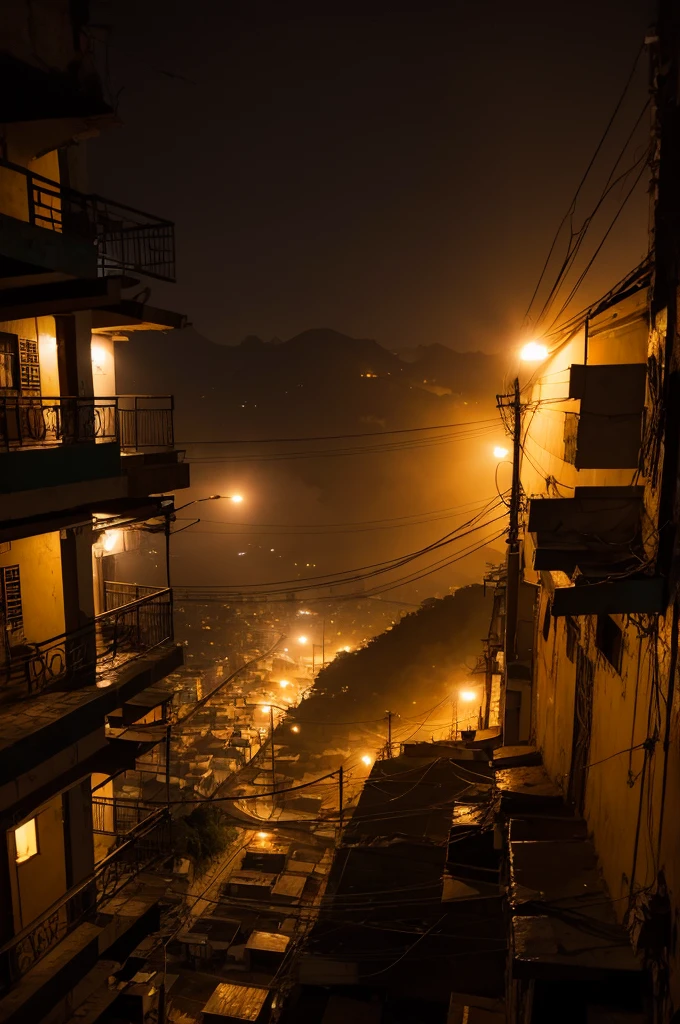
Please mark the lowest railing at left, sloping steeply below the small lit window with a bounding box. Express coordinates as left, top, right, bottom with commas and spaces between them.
0, 809, 171, 987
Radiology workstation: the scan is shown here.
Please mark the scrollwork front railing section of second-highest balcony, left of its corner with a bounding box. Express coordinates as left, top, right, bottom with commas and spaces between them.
0, 395, 119, 449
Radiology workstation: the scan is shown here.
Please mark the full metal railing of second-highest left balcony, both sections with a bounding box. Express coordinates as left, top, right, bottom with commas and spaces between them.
0, 394, 174, 452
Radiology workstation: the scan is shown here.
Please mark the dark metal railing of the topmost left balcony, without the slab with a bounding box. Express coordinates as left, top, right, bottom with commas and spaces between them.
0, 153, 175, 282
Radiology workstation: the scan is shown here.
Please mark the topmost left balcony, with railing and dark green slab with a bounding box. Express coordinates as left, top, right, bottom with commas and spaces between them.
0, 160, 175, 282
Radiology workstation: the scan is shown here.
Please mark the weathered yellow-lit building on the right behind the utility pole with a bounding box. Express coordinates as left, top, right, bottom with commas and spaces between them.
497, 4, 680, 1021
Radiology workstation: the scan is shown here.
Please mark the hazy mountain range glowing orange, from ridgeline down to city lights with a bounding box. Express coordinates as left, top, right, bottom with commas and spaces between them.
117, 328, 504, 601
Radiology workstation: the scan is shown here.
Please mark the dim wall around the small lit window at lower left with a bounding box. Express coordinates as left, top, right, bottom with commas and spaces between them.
7, 795, 67, 931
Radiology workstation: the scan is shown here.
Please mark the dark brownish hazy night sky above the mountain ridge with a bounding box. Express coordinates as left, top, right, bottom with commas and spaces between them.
91, 0, 652, 351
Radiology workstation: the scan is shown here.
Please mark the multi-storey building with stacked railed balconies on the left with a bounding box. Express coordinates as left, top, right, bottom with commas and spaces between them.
0, 0, 188, 1024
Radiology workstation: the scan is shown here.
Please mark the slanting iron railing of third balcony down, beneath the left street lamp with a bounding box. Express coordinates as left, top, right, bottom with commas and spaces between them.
0, 588, 173, 700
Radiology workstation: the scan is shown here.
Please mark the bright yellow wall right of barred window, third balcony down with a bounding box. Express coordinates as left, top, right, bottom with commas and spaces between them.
0, 534, 65, 642
